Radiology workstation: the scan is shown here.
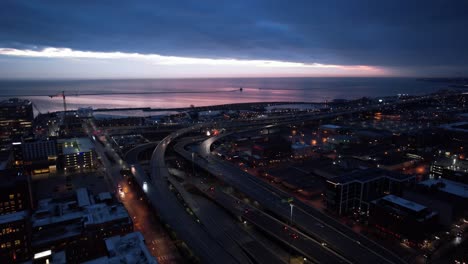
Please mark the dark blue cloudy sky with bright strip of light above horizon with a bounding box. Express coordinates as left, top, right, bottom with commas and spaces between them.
0, 0, 468, 79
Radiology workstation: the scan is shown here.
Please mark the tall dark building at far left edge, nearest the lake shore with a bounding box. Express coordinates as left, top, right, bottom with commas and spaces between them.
0, 98, 34, 150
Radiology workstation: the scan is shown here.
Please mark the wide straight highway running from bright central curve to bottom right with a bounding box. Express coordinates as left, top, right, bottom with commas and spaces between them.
195, 135, 405, 263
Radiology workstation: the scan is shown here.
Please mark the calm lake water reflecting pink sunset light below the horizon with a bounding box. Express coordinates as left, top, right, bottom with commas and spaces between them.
0, 78, 454, 112
